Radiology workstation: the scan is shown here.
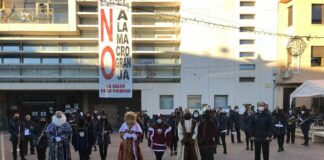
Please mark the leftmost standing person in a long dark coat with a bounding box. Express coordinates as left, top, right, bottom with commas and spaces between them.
9, 113, 26, 160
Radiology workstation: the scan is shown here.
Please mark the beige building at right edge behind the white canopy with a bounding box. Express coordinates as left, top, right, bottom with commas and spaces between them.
276, 0, 324, 108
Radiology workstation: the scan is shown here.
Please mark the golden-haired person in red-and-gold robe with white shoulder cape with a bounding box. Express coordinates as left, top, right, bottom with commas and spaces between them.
118, 112, 143, 160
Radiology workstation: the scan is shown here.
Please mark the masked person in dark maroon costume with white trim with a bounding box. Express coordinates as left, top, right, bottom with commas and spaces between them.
147, 114, 171, 160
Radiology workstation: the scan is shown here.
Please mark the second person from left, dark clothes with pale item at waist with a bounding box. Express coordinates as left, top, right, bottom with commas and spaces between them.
24, 114, 36, 155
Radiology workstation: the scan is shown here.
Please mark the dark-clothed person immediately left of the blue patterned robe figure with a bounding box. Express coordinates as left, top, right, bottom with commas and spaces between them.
34, 117, 48, 160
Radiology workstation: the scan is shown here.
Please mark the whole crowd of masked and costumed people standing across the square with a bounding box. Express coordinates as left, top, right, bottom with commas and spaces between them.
9, 102, 311, 160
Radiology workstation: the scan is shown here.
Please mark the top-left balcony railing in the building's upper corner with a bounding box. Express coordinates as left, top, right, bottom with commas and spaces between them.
0, 8, 55, 23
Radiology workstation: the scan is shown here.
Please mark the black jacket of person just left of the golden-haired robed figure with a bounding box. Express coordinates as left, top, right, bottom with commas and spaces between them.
96, 120, 113, 145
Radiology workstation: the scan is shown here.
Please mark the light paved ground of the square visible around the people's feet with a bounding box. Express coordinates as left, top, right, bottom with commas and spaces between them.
0, 133, 324, 160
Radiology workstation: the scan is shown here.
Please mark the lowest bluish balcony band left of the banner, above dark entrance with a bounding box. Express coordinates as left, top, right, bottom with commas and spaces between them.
0, 64, 98, 83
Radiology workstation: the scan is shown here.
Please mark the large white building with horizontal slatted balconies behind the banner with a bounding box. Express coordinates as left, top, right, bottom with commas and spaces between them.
0, 0, 278, 128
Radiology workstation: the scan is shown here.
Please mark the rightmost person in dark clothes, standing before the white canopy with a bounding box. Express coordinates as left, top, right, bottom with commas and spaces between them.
298, 106, 311, 146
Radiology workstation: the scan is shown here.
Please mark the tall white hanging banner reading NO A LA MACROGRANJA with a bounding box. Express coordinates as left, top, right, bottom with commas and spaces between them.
98, 0, 133, 98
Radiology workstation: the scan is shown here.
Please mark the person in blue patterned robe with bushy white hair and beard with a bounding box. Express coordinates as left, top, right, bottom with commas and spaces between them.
45, 111, 72, 160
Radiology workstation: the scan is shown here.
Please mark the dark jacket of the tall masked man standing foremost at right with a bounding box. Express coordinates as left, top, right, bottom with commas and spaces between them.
250, 111, 272, 141
